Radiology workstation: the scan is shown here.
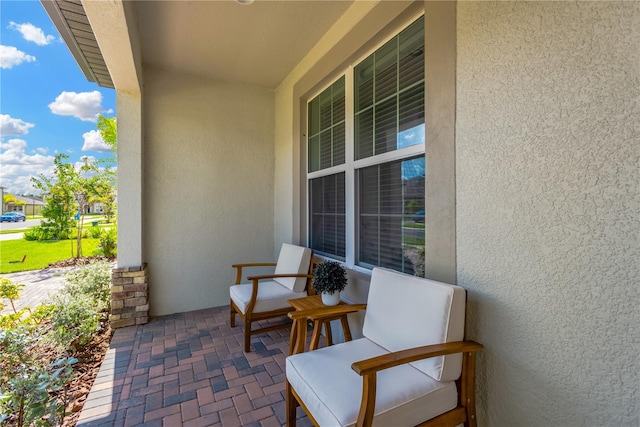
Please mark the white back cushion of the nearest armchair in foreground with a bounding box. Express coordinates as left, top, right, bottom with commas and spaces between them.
362, 268, 465, 381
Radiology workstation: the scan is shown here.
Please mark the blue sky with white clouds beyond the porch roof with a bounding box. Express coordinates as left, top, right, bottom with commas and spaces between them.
0, 0, 116, 195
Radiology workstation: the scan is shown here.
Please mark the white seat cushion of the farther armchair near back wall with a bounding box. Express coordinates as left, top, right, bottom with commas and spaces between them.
229, 280, 307, 313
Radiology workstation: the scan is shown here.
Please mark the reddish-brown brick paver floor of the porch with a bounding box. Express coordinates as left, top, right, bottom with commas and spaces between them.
77, 307, 310, 427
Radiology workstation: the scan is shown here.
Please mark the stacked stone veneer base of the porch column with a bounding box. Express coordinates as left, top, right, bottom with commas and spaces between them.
109, 263, 149, 329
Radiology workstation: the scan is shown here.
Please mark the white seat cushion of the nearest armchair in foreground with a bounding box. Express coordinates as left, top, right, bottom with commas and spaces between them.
286, 338, 458, 427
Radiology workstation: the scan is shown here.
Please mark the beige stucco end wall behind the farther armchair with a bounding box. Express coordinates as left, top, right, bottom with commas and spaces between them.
143, 68, 274, 315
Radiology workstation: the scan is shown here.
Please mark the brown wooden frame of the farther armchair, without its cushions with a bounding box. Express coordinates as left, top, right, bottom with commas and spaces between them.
229, 253, 315, 353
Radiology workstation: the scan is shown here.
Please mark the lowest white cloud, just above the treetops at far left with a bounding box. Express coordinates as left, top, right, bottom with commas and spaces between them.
0, 138, 54, 194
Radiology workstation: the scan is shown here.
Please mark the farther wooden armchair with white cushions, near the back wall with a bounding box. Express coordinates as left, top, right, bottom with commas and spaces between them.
229, 243, 313, 352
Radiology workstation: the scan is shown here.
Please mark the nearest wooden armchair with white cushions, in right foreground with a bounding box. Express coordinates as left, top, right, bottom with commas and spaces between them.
286, 268, 483, 426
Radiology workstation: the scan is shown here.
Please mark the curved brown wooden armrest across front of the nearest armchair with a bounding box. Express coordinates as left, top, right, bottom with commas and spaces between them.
351, 341, 483, 375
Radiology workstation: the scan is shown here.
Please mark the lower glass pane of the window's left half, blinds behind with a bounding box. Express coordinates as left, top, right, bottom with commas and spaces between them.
309, 173, 346, 259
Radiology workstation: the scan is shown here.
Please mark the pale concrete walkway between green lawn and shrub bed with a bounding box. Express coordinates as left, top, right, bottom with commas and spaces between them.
0, 267, 75, 314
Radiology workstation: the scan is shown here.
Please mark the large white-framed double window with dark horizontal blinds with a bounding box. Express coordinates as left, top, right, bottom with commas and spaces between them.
307, 17, 425, 275
